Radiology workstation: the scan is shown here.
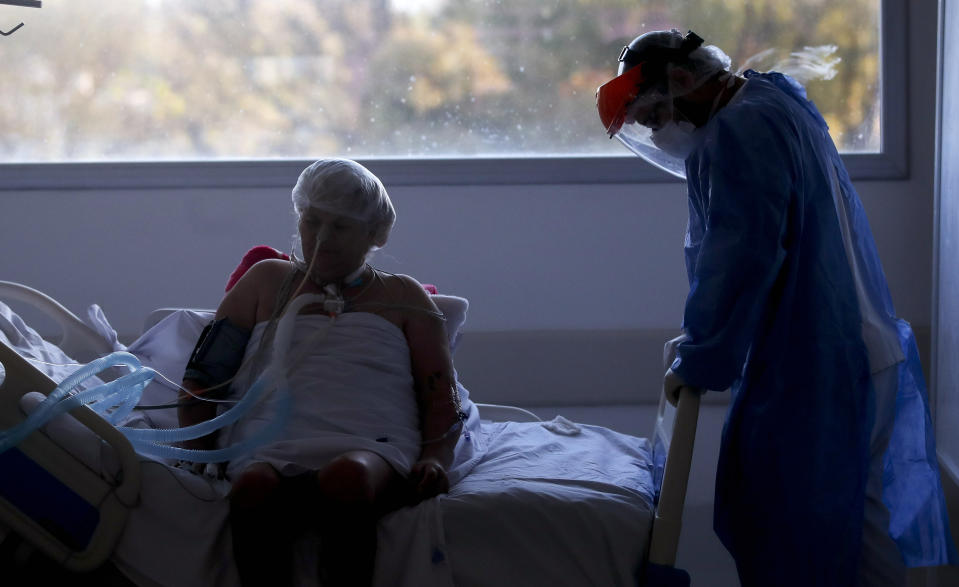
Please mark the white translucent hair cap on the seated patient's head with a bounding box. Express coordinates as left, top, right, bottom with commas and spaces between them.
293, 158, 396, 258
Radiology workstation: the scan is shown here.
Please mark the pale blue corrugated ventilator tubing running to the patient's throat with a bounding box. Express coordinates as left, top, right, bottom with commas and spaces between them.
0, 295, 325, 463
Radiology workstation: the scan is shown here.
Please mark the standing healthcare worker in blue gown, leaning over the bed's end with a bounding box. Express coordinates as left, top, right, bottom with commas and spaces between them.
597, 29, 957, 587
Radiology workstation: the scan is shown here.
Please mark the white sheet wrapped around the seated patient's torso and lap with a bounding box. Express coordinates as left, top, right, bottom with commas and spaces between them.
219, 312, 420, 477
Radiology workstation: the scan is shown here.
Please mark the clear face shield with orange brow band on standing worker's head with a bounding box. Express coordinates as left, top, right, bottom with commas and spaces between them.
596, 29, 703, 179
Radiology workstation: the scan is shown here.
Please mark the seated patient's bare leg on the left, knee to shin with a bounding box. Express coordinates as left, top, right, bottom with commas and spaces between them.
230, 463, 293, 587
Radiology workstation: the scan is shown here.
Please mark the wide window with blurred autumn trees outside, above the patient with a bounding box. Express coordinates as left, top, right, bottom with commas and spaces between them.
0, 0, 881, 162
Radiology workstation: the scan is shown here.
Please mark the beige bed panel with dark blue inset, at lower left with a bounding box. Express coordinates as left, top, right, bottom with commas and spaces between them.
0, 342, 140, 572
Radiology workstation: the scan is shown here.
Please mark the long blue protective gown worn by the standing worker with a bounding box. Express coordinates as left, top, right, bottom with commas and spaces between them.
672, 71, 956, 587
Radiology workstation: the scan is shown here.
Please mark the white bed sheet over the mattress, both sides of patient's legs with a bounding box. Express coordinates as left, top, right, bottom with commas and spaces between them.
99, 422, 652, 587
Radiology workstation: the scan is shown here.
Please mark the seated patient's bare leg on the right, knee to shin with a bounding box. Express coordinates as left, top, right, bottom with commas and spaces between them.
316, 451, 404, 587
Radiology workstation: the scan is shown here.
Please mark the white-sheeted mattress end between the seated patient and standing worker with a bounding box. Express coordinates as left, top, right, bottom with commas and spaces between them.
441, 422, 653, 587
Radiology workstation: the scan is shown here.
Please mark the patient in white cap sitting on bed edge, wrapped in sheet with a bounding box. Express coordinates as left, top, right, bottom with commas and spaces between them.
179, 159, 459, 585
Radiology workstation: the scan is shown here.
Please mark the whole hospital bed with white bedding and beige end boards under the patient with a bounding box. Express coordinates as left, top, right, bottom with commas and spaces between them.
0, 282, 700, 586
